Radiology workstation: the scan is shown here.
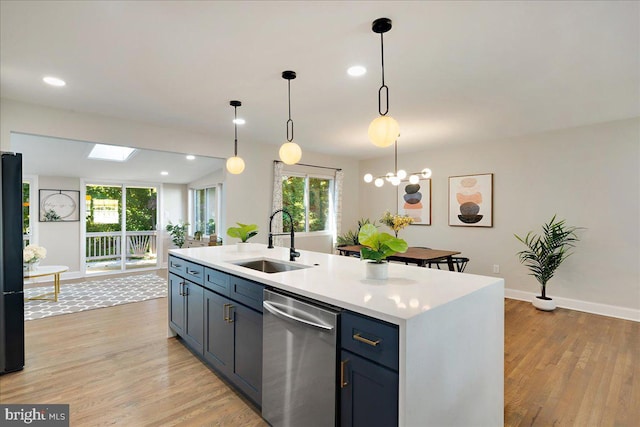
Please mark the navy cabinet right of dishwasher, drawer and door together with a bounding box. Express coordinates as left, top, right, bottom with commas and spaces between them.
339, 312, 399, 427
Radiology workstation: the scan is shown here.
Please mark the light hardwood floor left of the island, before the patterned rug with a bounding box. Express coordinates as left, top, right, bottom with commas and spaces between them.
0, 298, 267, 427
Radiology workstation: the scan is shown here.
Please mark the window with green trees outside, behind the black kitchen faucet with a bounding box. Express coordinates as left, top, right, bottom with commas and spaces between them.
282, 175, 333, 232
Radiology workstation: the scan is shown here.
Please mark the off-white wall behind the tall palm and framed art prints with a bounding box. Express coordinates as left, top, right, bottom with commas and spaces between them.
360, 118, 640, 320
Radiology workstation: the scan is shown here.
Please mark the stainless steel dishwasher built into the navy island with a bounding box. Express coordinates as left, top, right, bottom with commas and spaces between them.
262, 289, 340, 427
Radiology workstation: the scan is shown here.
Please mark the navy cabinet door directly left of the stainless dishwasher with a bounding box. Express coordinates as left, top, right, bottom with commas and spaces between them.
232, 304, 262, 405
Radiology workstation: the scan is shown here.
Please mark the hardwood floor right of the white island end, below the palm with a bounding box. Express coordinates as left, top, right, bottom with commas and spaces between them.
505, 300, 640, 427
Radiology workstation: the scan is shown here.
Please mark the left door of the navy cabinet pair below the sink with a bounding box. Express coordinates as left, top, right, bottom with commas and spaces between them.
204, 290, 233, 378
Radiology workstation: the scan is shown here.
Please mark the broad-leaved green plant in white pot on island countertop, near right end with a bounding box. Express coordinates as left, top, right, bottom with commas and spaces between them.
358, 224, 408, 280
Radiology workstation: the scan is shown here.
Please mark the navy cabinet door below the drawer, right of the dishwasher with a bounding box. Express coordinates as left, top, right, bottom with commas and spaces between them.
340, 350, 398, 427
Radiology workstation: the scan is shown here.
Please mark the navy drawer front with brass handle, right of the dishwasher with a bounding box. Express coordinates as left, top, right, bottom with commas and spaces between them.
341, 312, 399, 371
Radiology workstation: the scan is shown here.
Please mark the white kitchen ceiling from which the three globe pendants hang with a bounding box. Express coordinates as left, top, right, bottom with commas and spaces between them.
0, 1, 640, 158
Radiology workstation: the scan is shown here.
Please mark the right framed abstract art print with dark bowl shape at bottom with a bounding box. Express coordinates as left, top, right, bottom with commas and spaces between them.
449, 173, 493, 227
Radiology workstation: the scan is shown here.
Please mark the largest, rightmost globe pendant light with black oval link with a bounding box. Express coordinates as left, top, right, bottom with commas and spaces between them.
369, 18, 400, 147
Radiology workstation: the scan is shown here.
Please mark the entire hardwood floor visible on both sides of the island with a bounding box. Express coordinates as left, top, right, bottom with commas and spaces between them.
0, 298, 640, 427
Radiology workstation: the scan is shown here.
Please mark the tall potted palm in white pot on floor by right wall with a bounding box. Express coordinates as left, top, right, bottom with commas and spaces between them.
514, 215, 582, 311
